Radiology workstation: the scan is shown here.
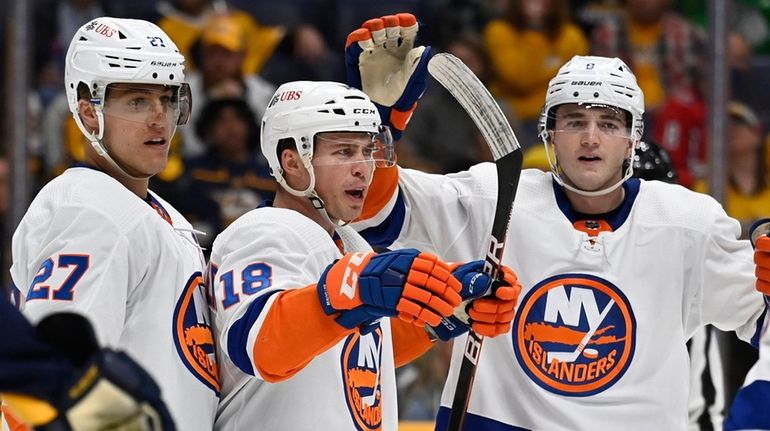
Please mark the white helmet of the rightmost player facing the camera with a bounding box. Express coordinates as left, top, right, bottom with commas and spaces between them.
538, 55, 644, 196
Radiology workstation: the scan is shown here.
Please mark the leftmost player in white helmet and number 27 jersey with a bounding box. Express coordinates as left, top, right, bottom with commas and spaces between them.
11, 17, 219, 430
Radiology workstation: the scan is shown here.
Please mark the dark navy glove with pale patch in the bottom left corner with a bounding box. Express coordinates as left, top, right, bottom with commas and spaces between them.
24, 313, 176, 431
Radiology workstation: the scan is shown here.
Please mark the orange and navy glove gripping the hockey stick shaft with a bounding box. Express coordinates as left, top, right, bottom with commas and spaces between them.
426, 260, 521, 341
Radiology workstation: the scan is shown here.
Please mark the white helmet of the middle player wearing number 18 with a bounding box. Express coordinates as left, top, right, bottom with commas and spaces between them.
260, 81, 392, 197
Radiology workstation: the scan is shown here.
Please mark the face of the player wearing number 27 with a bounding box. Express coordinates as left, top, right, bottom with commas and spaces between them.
103, 84, 179, 176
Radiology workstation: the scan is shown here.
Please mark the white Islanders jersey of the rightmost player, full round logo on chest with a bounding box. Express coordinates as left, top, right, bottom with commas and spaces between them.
356, 163, 764, 431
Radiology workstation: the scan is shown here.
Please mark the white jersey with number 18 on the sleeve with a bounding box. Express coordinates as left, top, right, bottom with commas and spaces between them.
210, 207, 398, 431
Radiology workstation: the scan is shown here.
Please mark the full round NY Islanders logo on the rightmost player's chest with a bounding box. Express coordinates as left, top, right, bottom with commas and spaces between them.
513, 274, 636, 396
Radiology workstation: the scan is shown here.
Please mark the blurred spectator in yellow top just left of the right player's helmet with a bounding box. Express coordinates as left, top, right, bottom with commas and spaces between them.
484, 0, 588, 146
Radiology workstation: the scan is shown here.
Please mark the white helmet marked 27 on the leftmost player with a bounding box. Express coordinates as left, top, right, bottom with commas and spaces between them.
64, 17, 192, 177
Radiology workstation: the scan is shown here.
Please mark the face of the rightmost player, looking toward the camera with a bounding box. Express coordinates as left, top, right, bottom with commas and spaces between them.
551, 104, 632, 191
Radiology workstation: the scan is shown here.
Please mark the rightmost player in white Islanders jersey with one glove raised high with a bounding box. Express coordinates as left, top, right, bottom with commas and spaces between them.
347, 17, 765, 430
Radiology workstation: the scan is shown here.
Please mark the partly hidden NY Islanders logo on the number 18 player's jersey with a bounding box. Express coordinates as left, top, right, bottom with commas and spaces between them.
341, 325, 382, 431
